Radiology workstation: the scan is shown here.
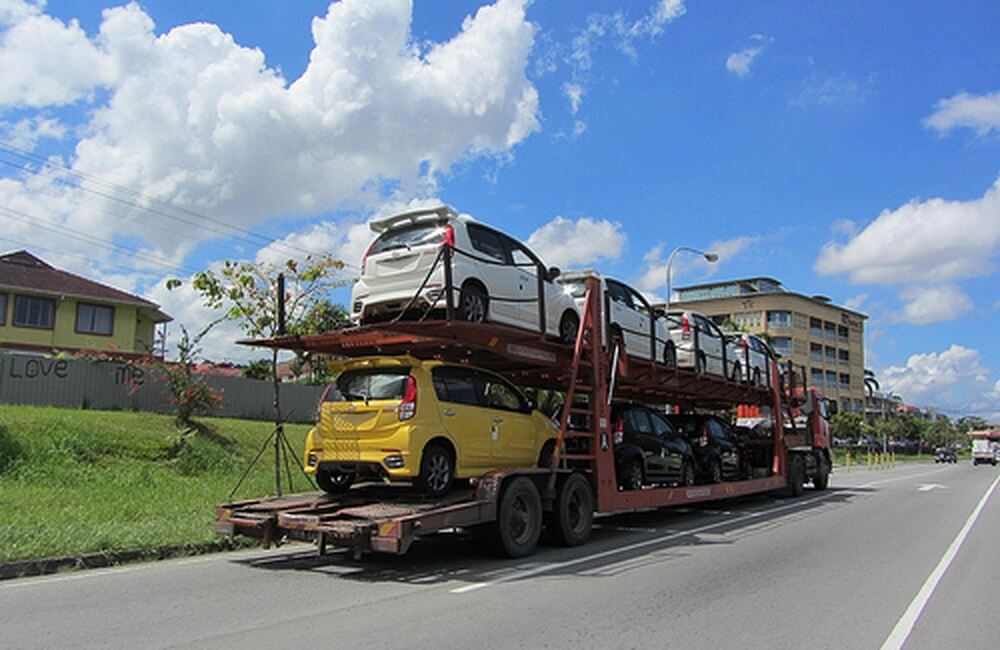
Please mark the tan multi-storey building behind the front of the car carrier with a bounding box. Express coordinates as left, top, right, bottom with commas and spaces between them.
671, 278, 868, 413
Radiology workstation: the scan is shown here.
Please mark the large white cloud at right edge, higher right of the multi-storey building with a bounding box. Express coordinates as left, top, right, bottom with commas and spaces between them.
814, 179, 1000, 284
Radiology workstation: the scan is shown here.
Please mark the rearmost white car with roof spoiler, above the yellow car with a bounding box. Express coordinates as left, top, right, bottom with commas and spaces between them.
351, 206, 580, 342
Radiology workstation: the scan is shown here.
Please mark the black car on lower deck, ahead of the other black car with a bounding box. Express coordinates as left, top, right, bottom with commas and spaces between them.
666, 413, 745, 483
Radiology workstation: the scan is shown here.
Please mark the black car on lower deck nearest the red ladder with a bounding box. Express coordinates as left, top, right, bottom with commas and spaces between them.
611, 404, 697, 490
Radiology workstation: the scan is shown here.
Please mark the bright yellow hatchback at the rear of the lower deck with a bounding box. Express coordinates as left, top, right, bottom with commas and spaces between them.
305, 356, 558, 496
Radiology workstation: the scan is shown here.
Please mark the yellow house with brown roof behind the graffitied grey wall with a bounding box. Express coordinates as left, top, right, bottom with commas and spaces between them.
0, 251, 172, 356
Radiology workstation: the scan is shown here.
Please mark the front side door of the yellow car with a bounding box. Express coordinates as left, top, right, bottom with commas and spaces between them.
478, 371, 543, 467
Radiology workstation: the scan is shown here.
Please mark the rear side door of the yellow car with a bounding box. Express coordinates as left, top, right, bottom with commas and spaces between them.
431, 366, 497, 472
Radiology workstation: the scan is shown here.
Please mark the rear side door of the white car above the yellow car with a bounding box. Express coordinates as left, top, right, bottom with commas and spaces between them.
464, 223, 523, 327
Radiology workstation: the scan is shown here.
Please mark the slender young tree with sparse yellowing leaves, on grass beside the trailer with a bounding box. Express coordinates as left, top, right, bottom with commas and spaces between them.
178, 255, 346, 496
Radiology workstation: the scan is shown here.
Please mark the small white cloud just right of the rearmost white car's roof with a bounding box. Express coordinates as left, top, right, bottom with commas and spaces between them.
527, 216, 626, 267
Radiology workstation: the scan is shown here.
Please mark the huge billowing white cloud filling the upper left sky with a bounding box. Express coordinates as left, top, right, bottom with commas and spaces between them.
0, 0, 540, 270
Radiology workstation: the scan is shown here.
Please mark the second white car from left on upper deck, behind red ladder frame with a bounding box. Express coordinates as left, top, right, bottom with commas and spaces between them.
559, 270, 674, 365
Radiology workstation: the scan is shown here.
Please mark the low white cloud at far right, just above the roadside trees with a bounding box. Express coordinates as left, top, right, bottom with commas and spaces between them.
878, 344, 996, 412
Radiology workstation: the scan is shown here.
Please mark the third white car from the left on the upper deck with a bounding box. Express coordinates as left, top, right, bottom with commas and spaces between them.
658, 305, 733, 377
